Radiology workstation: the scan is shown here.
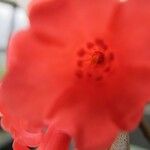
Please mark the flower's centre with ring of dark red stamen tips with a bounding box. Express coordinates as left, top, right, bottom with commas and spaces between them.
76, 39, 114, 81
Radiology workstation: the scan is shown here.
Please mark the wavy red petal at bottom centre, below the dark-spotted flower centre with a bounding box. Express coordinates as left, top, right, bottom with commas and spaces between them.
47, 85, 120, 150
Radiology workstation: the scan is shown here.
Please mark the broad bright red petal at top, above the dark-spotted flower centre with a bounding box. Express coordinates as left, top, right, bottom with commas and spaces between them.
29, 0, 118, 41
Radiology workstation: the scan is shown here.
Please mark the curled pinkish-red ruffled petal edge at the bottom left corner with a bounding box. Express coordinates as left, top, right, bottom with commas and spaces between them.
1, 114, 42, 147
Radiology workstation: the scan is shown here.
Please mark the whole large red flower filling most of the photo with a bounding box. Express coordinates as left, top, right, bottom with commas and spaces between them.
0, 0, 150, 150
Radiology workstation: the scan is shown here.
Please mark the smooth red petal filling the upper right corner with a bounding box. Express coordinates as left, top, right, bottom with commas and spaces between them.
109, 0, 150, 65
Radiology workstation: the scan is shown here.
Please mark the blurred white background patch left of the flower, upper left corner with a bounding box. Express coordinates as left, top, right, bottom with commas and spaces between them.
0, 1, 28, 73
